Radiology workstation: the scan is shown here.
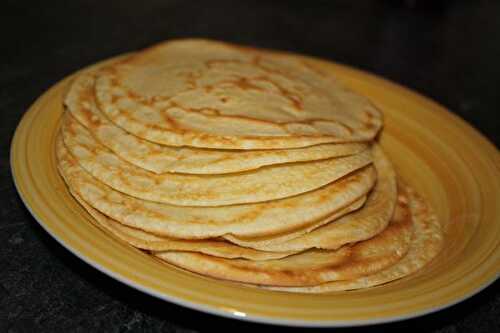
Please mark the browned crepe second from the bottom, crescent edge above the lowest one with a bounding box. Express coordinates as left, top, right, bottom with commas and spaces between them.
155, 188, 413, 287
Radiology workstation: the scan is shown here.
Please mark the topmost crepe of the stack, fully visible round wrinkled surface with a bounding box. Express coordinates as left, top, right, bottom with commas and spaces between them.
95, 39, 382, 149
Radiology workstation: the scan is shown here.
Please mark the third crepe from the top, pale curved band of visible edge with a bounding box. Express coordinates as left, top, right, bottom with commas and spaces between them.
61, 113, 372, 206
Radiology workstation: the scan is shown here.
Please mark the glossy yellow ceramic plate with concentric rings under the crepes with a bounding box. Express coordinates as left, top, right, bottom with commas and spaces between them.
11, 53, 500, 326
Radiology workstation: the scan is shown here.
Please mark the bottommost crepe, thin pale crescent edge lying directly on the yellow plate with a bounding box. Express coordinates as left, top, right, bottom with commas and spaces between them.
271, 187, 444, 293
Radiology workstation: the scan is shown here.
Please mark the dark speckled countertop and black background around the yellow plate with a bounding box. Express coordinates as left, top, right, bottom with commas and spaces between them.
0, 0, 500, 332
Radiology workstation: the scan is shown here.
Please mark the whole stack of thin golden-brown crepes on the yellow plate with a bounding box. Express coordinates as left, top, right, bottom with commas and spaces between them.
56, 39, 442, 292
